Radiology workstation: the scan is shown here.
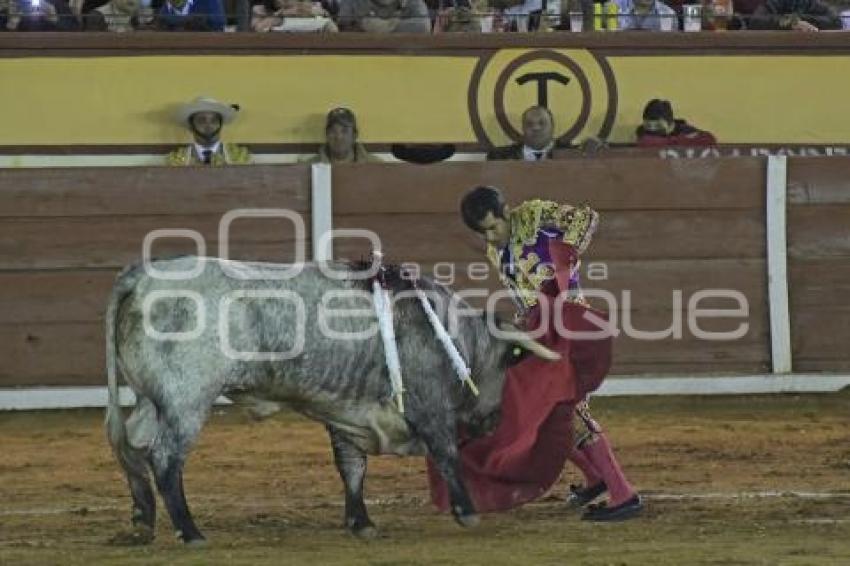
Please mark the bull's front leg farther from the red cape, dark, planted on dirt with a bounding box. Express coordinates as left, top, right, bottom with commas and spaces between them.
328, 426, 377, 538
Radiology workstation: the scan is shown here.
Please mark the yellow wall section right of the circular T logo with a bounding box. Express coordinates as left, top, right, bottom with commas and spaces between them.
611, 55, 850, 143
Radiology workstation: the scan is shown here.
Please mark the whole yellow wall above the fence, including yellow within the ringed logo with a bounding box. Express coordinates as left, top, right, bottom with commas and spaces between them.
0, 50, 850, 145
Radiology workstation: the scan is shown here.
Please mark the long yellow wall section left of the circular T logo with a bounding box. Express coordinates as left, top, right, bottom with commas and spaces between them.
0, 56, 476, 145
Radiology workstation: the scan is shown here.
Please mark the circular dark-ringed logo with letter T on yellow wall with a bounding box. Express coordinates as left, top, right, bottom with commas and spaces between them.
468, 49, 617, 147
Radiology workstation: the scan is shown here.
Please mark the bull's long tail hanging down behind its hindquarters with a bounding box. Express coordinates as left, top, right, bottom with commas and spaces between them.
106, 266, 147, 477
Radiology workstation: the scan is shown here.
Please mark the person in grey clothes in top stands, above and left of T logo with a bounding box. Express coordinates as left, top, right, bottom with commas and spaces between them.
337, 0, 431, 33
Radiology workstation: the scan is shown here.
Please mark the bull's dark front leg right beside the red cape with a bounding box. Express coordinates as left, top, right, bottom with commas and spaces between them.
416, 416, 481, 527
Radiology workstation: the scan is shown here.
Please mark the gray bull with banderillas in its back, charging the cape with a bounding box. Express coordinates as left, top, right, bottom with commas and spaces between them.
106, 257, 557, 542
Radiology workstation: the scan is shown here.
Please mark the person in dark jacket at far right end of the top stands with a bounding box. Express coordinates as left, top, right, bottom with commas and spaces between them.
749, 0, 841, 31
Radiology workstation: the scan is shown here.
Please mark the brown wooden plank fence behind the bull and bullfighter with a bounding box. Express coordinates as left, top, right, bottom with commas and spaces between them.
0, 157, 850, 387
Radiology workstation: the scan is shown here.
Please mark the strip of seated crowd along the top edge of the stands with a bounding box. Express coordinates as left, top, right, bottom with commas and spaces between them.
0, 0, 850, 33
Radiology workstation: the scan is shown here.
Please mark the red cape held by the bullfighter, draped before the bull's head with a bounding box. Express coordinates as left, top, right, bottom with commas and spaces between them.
428, 303, 611, 512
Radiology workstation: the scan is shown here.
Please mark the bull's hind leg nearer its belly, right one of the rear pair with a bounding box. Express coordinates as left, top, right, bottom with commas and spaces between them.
151, 422, 204, 543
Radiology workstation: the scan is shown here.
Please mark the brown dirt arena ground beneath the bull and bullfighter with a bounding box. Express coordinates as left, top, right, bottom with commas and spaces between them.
0, 393, 850, 566
